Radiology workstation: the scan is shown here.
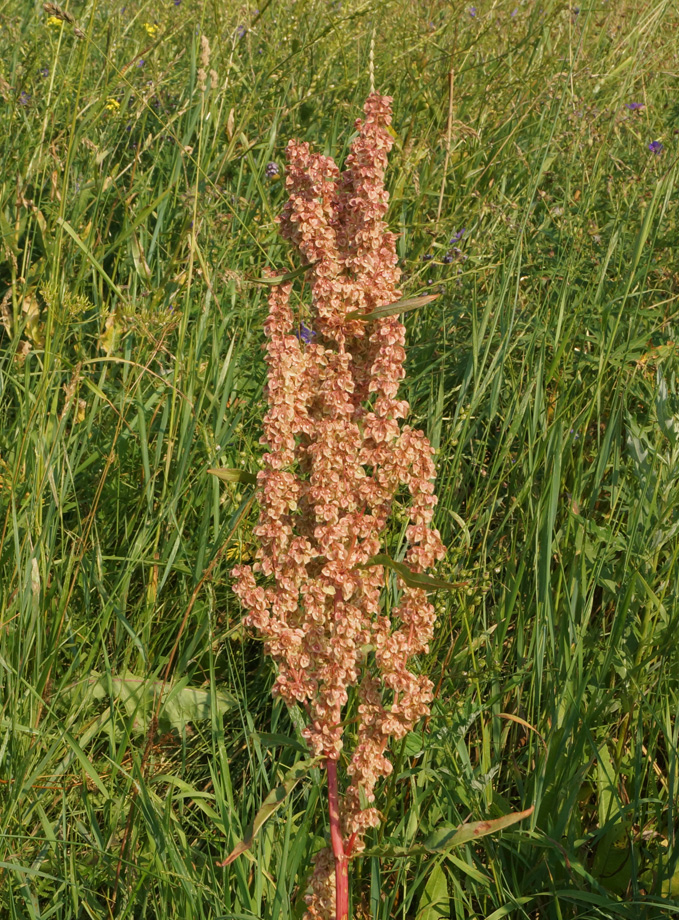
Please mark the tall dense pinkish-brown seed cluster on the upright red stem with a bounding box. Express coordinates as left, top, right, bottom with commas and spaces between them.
233, 94, 444, 920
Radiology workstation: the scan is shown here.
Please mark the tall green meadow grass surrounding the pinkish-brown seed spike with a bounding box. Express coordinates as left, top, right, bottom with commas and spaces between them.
0, 0, 679, 920
